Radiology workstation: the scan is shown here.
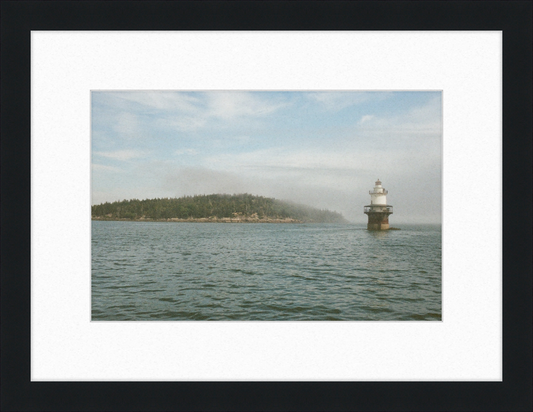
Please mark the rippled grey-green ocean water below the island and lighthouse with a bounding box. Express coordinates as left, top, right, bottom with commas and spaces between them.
91, 221, 442, 321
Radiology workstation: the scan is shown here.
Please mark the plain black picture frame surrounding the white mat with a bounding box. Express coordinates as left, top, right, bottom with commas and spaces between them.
1, 1, 533, 411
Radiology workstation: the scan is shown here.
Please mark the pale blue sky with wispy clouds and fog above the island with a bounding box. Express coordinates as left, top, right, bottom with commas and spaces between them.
91, 91, 442, 226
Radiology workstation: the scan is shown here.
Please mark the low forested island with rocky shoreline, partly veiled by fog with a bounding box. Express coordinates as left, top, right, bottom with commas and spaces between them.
91, 194, 348, 223
